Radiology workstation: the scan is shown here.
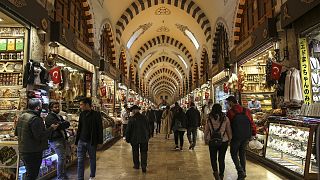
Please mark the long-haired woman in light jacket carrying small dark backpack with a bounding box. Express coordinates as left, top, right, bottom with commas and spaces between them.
204, 104, 232, 180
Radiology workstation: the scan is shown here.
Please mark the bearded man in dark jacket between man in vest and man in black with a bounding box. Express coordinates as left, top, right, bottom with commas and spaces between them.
45, 102, 70, 180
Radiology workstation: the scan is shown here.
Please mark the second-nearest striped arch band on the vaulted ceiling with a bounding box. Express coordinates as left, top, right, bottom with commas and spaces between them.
134, 35, 192, 64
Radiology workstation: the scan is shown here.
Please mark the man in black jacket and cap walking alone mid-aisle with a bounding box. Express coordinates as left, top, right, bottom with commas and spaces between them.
126, 105, 149, 173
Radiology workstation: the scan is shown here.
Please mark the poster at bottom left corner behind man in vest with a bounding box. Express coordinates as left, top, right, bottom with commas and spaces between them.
0, 145, 19, 180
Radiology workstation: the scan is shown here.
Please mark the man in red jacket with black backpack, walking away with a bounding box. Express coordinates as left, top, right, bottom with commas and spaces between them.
226, 96, 257, 179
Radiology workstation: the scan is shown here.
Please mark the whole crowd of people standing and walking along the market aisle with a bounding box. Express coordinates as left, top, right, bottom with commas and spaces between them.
15, 96, 256, 180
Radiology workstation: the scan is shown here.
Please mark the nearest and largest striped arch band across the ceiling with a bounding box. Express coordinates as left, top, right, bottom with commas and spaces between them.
116, 0, 211, 44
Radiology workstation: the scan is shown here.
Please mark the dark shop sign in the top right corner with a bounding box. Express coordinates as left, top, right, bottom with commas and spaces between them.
281, 0, 320, 27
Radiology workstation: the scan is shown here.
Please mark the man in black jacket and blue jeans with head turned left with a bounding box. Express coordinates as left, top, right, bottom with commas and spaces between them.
76, 98, 103, 180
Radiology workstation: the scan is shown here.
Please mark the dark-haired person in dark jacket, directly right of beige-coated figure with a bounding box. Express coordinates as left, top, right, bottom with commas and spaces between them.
171, 102, 187, 151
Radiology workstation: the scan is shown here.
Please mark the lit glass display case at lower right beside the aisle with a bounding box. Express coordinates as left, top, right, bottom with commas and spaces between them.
265, 119, 318, 179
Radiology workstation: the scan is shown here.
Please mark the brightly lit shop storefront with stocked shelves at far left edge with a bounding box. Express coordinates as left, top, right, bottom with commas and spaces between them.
0, 0, 49, 179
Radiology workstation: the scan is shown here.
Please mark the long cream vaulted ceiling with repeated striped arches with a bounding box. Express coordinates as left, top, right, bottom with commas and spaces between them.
103, 0, 226, 103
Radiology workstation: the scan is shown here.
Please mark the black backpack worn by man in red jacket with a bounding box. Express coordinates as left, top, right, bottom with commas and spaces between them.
231, 108, 252, 141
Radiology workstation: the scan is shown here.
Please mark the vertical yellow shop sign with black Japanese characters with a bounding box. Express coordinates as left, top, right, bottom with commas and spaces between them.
299, 38, 312, 105
